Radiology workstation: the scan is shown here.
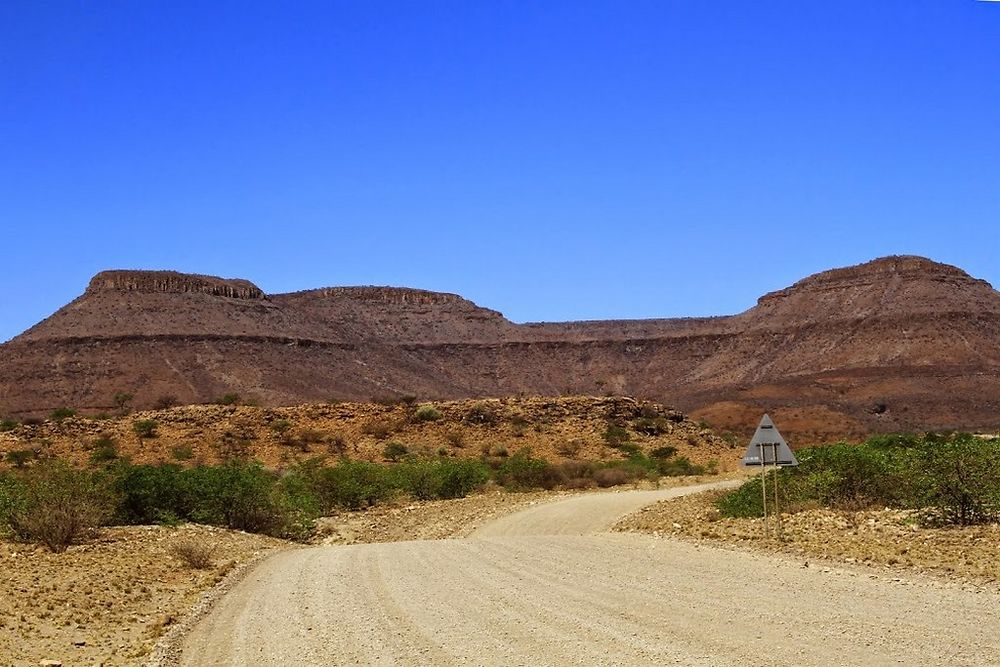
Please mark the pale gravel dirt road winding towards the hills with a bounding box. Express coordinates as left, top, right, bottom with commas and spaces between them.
182, 489, 1000, 667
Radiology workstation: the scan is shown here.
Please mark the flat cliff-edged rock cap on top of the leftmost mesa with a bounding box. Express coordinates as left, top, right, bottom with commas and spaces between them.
86, 270, 267, 299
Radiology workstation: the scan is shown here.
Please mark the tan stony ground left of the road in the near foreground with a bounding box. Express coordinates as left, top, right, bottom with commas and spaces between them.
0, 525, 285, 667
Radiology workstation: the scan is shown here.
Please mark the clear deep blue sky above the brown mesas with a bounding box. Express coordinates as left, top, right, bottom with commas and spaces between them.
0, 0, 1000, 340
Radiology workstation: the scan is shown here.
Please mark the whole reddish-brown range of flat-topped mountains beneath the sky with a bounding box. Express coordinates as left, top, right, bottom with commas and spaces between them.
0, 256, 1000, 439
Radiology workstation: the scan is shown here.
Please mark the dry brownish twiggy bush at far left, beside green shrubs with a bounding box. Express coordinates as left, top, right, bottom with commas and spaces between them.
6, 461, 114, 552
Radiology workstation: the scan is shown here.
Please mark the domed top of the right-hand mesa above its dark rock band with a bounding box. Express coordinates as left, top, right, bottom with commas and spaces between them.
738, 256, 1000, 328
